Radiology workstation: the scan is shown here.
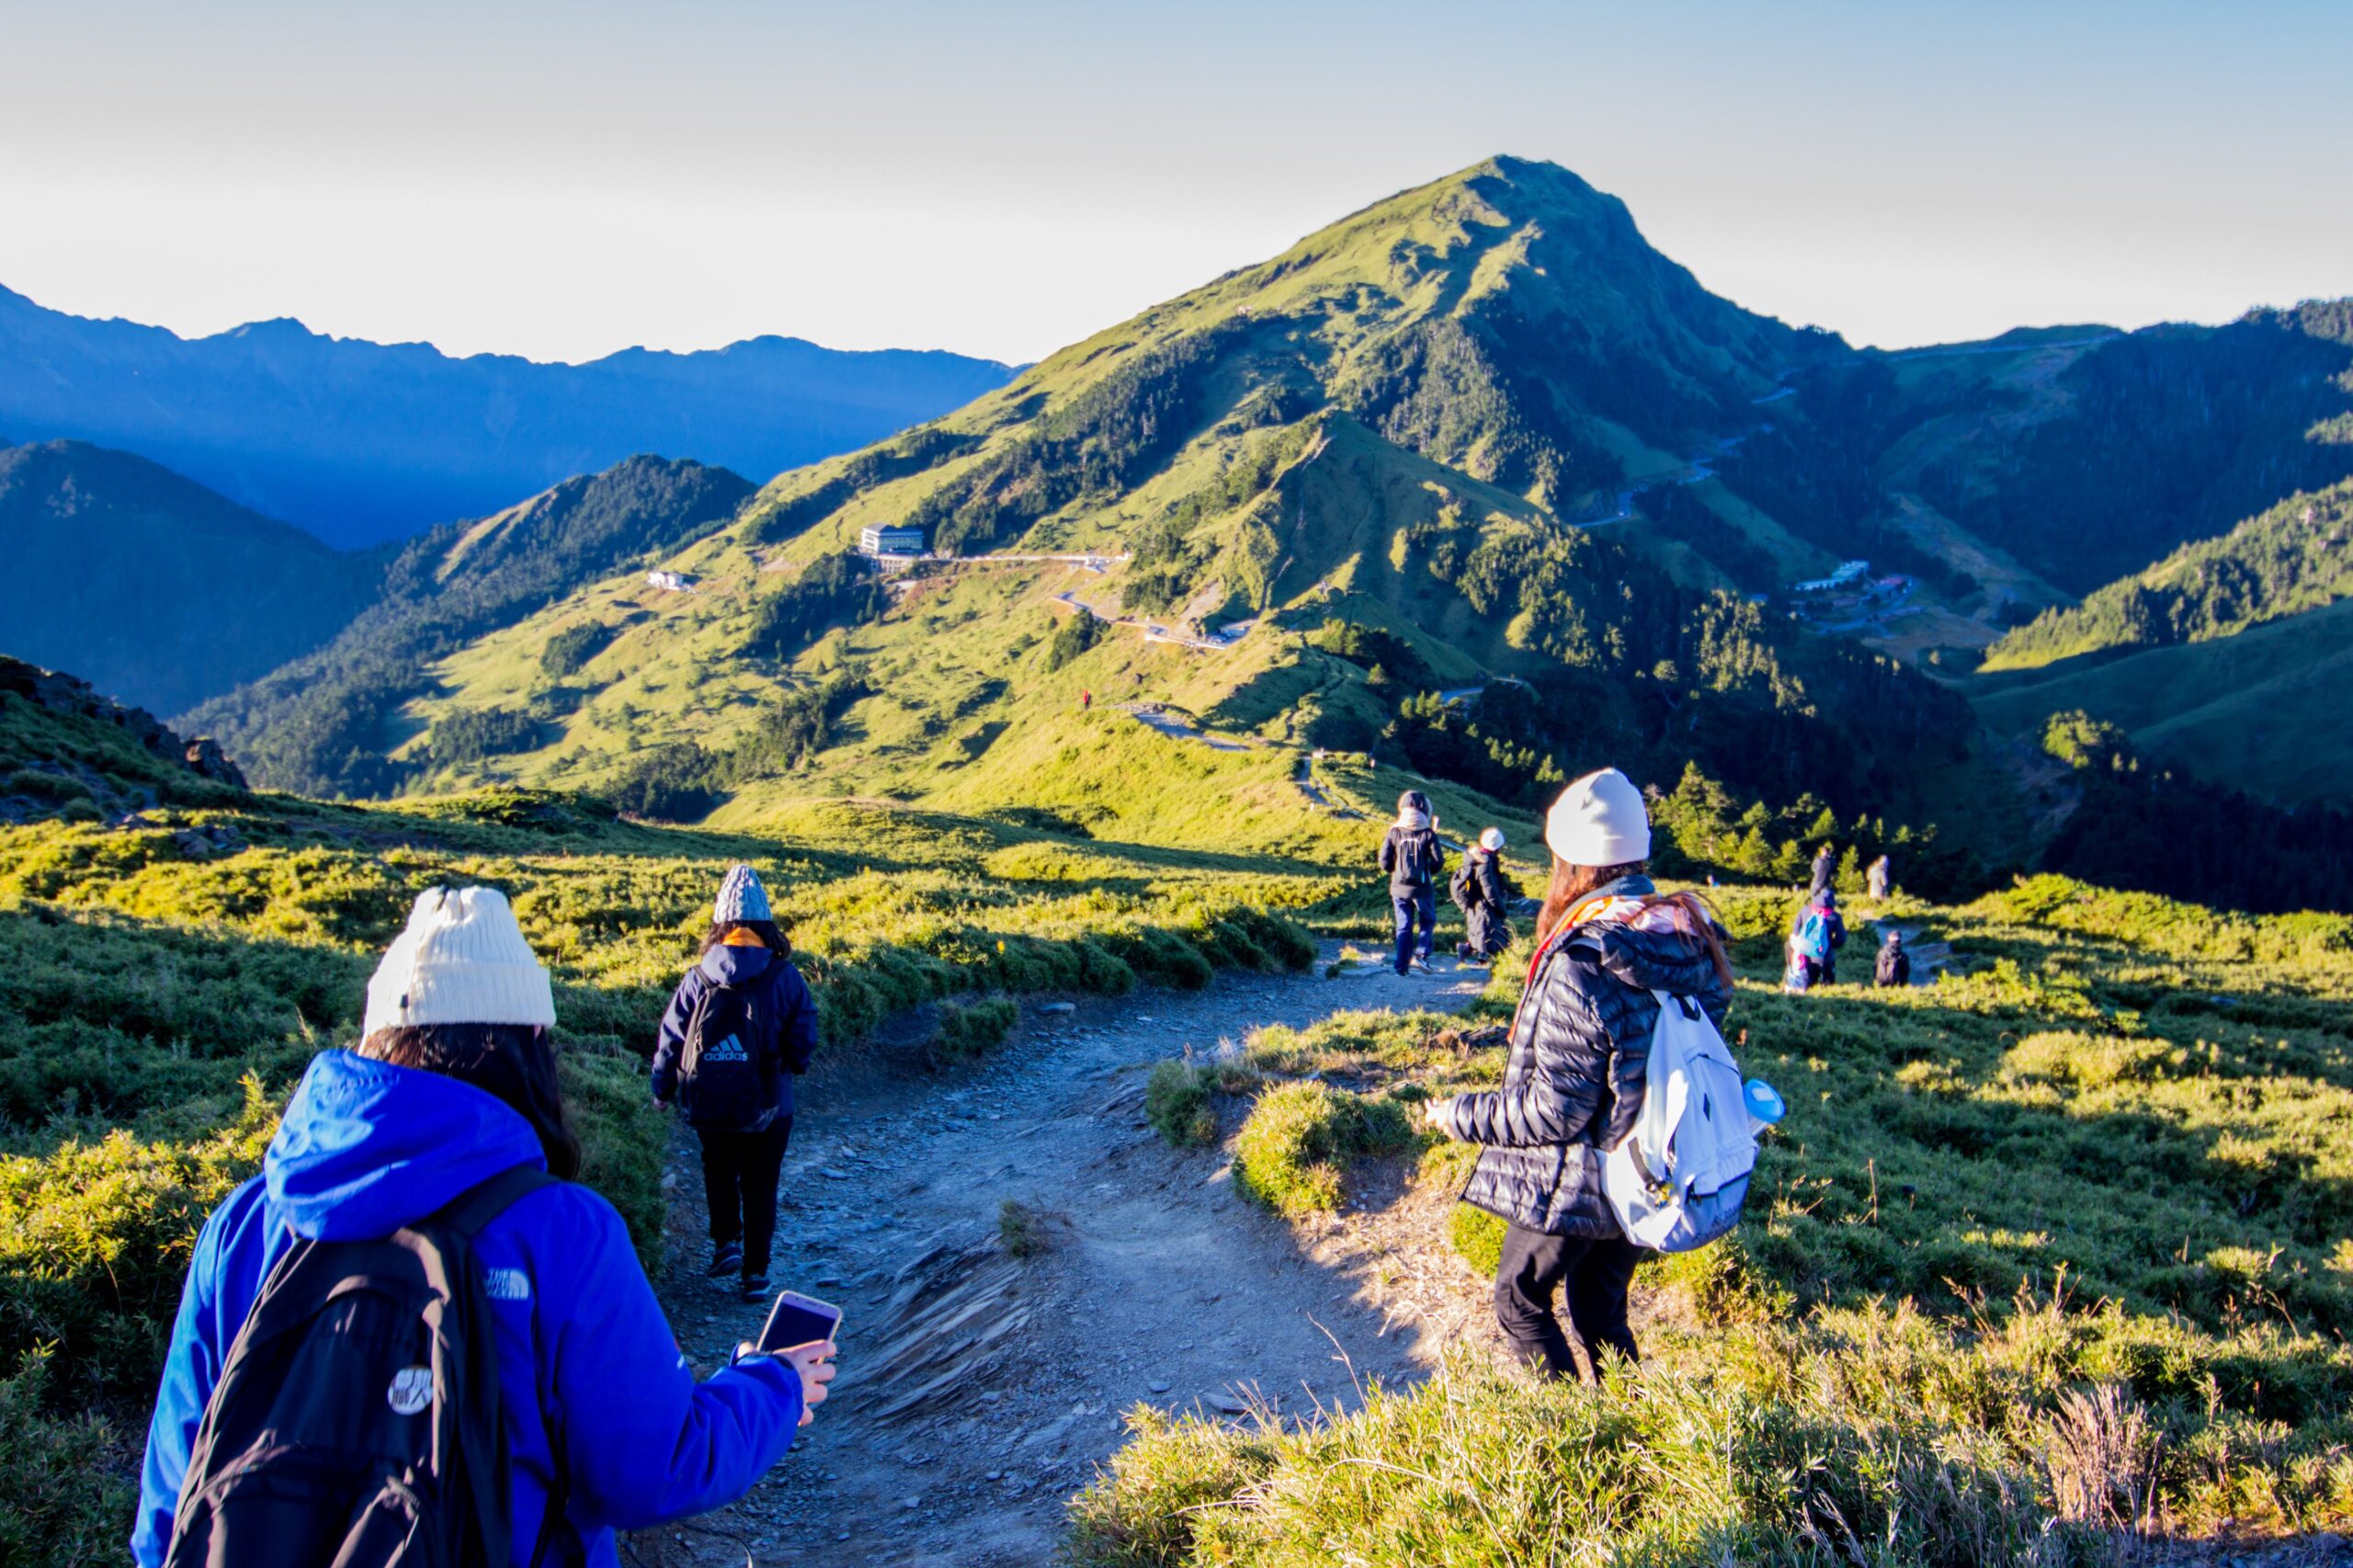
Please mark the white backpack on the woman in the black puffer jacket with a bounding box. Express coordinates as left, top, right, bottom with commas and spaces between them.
1602, 991, 1757, 1253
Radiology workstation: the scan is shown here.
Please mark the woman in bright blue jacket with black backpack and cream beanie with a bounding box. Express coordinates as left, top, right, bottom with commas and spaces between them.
131, 888, 833, 1568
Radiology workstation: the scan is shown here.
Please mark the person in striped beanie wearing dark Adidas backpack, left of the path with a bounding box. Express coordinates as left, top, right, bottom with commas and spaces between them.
654, 867, 816, 1302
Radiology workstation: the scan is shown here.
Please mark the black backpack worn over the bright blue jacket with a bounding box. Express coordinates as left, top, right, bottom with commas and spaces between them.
165, 1165, 564, 1568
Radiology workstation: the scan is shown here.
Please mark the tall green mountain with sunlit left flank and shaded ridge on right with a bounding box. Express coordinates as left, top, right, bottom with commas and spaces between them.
207, 160, 2344, 900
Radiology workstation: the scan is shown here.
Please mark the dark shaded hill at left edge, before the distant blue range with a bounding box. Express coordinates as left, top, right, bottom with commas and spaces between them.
0, 440, 383, 713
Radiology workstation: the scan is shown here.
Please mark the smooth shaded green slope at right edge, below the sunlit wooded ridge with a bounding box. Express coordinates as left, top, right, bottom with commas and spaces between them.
1972, 588, 2353, 805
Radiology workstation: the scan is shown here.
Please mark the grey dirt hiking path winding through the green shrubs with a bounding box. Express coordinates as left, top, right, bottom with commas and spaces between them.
633, 949, 1484, 1568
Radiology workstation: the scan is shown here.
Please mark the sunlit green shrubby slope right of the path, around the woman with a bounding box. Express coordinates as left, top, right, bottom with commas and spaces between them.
1071, 878, 2353, 1568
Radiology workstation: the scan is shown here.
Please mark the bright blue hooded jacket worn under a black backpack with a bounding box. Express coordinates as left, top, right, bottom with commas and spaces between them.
131, 1050, 800, 1568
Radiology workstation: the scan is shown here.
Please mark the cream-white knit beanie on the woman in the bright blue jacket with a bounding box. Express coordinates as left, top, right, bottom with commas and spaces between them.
360, 888, 555, 1039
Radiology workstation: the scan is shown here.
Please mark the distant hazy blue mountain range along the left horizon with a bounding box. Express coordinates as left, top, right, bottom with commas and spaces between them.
0, 288, 1012, 549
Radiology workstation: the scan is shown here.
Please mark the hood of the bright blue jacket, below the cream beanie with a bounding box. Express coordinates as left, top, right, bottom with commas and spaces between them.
261, 1050, 546, 1241
